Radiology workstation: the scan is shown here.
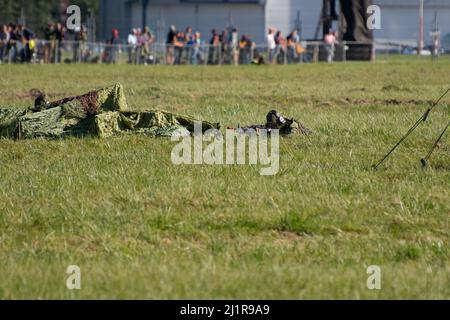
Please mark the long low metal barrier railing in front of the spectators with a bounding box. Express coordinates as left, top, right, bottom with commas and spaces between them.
0, 40, 442, 65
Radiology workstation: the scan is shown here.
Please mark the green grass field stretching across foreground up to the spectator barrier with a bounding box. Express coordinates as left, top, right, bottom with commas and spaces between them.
0, 60, 450, 299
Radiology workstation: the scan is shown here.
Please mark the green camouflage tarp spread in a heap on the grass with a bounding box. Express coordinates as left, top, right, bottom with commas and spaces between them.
0, 84, 220, 139
